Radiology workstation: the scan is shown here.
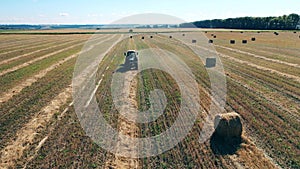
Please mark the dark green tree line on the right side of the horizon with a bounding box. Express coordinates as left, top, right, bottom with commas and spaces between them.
186, 14, 300, 30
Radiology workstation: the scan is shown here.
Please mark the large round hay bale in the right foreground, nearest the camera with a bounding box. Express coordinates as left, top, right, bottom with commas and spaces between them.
215, 112, 243, 139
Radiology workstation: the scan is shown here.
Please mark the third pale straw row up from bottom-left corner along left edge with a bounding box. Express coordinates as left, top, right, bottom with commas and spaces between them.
0, 40, 84, 76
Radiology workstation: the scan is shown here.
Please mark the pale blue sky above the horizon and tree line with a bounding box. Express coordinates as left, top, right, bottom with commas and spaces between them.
0, 0, 300, 24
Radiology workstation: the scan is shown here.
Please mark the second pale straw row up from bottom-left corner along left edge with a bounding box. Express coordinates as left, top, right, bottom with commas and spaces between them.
0, 34, 113, 103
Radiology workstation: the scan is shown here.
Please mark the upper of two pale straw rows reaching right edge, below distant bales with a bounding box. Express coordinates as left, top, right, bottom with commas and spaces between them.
214, 45, 300, 68
